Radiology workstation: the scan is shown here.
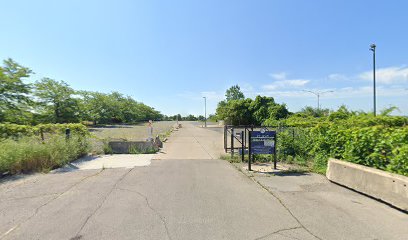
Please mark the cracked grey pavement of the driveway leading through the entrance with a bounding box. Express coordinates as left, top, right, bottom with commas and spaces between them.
0, 123, 408, 240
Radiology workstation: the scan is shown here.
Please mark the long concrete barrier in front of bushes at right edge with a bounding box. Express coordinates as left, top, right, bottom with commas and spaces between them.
326, 159, 408, 211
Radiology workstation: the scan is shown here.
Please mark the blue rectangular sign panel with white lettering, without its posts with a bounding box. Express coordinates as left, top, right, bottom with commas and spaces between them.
250, 130, 276, 154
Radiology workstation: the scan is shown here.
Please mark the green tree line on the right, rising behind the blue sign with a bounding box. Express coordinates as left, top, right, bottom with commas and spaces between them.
213, 85, 407, 126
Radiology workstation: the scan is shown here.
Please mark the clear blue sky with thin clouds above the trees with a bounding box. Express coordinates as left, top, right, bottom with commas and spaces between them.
0, 0, 408, 115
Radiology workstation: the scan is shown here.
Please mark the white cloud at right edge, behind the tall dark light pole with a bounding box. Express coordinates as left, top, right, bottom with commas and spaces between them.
358, 67, 408, 84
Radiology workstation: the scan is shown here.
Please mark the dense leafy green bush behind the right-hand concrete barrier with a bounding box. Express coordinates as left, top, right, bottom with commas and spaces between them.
278, 117, 408, 176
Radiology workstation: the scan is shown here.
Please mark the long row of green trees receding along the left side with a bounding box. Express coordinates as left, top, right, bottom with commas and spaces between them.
0, 58, 164, 125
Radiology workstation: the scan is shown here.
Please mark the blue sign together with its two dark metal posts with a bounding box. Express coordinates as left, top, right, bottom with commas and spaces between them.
248, 129, 277, 171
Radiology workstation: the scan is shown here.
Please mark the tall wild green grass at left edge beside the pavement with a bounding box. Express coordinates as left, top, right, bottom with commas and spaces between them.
0, 135, 90, 174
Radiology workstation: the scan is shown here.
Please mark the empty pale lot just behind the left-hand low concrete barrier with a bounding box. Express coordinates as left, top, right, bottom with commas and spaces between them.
89, 121, 176, 141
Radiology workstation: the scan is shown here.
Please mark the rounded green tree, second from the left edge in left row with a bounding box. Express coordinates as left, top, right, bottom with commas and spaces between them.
34, 78, 80, 123
